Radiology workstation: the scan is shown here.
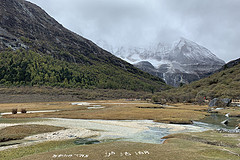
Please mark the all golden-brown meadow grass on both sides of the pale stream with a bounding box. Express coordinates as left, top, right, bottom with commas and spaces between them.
0, 99, 240, 160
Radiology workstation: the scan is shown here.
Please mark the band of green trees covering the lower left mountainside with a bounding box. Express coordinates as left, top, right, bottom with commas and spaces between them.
0, 49, 169, 91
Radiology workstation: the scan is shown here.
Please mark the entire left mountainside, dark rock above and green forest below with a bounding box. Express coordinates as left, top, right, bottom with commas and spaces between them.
0, 0, 168, 91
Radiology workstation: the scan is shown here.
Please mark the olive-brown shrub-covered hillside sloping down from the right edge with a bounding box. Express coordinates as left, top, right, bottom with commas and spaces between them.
155, 60, 240, 102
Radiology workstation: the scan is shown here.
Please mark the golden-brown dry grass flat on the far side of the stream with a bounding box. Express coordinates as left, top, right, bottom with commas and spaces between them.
0, 100, 207, 124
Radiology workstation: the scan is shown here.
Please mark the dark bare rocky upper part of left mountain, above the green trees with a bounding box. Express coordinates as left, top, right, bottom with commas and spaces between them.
0, 0, 121, 63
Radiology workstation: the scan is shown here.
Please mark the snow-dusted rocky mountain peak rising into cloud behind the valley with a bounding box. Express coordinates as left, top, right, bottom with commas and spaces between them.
99, 38, 225, 86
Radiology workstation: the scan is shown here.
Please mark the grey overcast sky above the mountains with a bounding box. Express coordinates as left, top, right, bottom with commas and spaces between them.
29, 0, 240, 62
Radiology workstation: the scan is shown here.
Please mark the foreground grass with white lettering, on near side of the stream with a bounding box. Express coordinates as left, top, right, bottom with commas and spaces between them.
0, 131, 240, 160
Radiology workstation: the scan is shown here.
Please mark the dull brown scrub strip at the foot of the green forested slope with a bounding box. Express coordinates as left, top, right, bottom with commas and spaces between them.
0, 86, 153, 103
